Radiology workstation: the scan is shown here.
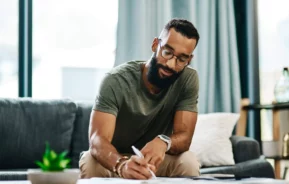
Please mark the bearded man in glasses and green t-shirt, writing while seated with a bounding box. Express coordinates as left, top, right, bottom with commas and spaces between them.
79, 19, 199, 179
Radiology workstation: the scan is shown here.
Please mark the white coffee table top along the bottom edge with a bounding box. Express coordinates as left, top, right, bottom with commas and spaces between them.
0, 178, 289, 184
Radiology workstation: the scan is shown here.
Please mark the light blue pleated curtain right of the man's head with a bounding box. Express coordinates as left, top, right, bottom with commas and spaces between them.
191, 0, 241, 113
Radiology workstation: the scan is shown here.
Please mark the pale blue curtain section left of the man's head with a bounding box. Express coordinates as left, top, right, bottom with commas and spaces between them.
115, 0, 172, 66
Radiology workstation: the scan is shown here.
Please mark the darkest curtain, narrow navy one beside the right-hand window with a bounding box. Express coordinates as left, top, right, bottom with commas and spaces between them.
234, 0, 262, 140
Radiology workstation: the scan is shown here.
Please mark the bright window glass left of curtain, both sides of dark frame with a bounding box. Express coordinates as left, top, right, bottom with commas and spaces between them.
0, 0, 118, 100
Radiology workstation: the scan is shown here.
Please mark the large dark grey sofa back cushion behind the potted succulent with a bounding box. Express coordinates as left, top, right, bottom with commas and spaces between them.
0, 98, 76, 169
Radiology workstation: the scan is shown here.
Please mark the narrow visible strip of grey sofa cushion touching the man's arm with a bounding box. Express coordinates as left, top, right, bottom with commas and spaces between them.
71, 102, 93, 168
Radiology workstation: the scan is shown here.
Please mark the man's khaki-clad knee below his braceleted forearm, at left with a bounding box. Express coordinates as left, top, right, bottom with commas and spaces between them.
79, 151, 111, 178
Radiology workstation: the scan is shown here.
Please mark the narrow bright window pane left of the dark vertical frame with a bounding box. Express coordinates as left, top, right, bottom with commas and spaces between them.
0, 0, 18, 98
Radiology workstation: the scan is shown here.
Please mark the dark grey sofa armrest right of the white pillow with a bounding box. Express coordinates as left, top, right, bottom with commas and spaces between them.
230, 136, 260, 163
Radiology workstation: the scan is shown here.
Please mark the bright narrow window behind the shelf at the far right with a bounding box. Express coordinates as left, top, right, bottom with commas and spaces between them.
258, 0, 289, 140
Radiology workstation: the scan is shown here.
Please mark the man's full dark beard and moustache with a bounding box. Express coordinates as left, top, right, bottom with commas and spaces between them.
147, 54, 183, 89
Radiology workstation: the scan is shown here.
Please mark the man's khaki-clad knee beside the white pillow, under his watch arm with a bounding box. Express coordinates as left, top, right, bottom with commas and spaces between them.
175, 151, 200, 176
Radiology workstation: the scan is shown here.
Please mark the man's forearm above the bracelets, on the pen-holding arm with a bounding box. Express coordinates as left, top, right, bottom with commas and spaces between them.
90, 135, 122, 171
